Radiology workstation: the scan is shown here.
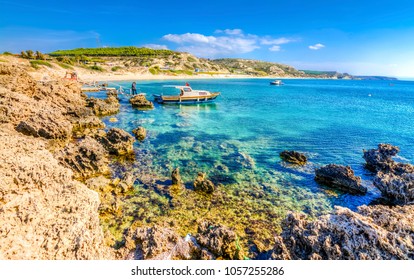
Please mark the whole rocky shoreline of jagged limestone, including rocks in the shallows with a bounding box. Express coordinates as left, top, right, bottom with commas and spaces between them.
0, 59, 414, 259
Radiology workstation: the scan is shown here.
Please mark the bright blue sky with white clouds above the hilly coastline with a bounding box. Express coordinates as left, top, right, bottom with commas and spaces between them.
0, 0, 414, 77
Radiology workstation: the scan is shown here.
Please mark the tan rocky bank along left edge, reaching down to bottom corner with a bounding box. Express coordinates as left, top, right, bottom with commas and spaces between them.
0, 64, 113, 260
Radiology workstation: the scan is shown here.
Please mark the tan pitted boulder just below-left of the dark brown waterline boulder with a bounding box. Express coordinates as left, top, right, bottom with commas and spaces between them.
57, 136, 110, 179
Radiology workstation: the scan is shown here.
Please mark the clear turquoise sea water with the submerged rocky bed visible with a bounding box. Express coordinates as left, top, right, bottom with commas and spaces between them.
95, 79, 414, 219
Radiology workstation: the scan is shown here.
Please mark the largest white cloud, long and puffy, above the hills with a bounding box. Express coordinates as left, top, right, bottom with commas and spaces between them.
162, 29, 294, 58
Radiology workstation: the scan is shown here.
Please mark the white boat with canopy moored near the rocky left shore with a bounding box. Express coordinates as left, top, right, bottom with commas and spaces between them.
154, 86, 220, 104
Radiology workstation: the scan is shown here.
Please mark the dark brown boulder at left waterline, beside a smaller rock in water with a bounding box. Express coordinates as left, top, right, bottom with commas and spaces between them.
97, 128, 135, 156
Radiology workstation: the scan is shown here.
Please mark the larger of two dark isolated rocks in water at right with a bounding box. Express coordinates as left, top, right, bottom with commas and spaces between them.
315, 164, 367, 194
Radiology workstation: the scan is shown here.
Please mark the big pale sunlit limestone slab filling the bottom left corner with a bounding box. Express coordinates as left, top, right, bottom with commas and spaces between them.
0, 127, 112, 260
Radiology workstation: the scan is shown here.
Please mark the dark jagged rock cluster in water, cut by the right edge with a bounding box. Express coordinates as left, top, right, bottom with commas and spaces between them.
364, 144, 414, 204
